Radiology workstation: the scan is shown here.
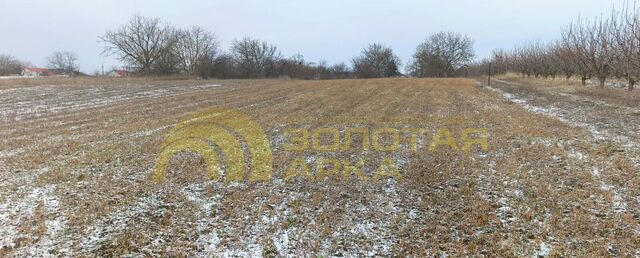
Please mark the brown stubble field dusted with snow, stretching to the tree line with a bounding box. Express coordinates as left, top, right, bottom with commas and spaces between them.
0, 76, 640, 257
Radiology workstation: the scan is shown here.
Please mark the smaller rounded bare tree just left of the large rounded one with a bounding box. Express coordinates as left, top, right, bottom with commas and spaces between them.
352, 43, 400, 78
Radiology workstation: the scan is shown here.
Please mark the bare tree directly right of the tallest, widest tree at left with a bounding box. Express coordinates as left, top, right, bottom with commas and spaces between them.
174, 26, 219, 75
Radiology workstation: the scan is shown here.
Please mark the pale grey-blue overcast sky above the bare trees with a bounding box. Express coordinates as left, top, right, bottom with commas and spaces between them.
0, 0, 623, 73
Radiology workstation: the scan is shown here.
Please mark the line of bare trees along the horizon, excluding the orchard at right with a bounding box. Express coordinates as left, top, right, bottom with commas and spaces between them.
0, 15, 475, 80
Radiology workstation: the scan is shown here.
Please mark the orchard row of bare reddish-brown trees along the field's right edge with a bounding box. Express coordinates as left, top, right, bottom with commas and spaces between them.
474, 4, 640, 90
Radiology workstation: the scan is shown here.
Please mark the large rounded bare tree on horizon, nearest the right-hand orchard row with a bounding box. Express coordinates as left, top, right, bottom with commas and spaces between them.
409, 32, 475, 77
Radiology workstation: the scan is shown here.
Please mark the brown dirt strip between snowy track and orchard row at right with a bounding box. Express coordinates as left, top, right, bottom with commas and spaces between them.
493, 73, 640, 150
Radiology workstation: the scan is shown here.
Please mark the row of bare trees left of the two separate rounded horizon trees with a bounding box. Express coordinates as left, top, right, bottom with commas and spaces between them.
100, 15, 347, 79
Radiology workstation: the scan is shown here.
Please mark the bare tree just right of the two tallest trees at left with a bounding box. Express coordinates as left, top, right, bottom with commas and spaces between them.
231, 38, 281, 78
